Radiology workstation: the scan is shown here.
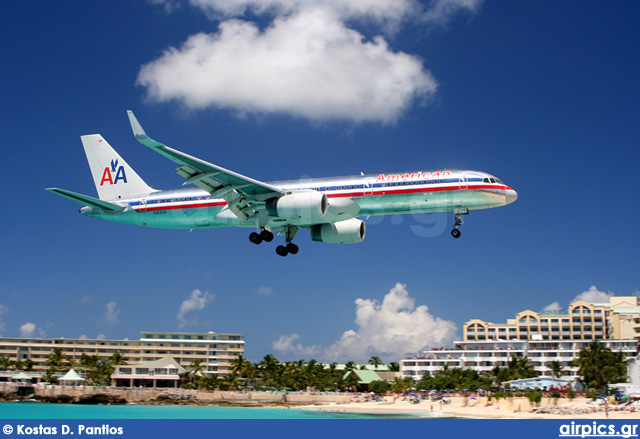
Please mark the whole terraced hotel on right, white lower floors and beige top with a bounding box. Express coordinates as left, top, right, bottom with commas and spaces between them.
400, 296, 640, 381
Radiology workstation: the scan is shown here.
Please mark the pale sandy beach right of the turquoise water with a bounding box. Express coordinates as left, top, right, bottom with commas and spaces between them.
299, 397, 640, 420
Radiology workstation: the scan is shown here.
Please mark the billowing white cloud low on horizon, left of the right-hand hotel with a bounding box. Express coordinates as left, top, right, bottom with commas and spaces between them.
272, 283, 456, 362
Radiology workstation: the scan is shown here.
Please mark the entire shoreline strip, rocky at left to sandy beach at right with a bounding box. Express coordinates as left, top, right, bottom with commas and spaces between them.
0, 385, 640, 420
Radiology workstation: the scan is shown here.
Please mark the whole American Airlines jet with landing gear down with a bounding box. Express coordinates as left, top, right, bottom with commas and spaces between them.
46, 111, 518, 256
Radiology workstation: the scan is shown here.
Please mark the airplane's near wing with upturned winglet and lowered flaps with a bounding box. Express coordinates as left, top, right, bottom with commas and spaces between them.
127, 110, 285, 221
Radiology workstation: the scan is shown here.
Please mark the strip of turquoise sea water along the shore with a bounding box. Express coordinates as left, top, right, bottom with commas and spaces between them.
0, 402, 450, 419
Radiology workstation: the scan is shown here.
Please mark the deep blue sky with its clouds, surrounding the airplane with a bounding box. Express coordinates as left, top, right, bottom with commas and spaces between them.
0, 0, 640, 361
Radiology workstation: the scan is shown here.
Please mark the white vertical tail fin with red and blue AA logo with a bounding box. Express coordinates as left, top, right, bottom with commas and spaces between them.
81, 134, 153, 200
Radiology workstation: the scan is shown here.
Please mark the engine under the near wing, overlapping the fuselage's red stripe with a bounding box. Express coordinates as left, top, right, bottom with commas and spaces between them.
266, 191, 329, 220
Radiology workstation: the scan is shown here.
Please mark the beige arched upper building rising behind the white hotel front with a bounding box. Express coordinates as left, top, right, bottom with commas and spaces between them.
463, 296, 640, 341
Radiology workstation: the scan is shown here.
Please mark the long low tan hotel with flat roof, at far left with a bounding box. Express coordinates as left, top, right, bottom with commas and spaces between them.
0, 332, 244, 376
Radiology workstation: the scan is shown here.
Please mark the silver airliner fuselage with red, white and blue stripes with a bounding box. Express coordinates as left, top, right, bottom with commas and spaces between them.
80, 170, 517, 229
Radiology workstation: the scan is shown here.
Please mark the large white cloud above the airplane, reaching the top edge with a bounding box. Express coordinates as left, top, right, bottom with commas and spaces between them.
137, 0, 479, 123
